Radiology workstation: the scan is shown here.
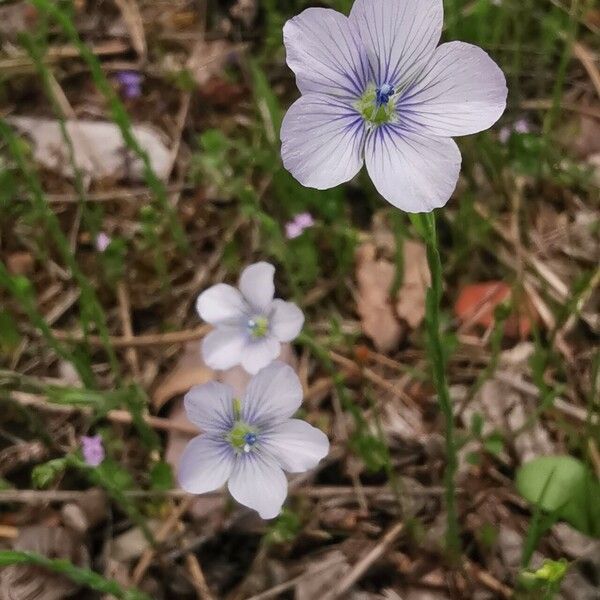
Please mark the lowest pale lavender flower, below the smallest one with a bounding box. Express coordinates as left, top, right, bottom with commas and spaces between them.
178, 362, 329, 519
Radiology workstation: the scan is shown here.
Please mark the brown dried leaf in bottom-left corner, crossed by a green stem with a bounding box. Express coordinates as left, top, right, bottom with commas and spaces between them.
0, 525, 90, 600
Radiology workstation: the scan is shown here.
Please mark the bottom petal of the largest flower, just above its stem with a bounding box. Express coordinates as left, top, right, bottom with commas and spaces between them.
365, 125, 461, 213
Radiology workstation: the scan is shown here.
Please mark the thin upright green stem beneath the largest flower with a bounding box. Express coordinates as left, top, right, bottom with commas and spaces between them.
411, 213, 460, 559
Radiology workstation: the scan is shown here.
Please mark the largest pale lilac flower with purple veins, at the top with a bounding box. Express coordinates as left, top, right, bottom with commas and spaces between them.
281, 0, 507, 212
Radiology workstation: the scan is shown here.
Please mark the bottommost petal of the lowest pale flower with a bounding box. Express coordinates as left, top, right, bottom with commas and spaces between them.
228, 452, 287, 519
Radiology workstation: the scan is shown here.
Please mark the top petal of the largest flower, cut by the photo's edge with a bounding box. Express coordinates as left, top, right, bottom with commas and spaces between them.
350, 0, 444, 91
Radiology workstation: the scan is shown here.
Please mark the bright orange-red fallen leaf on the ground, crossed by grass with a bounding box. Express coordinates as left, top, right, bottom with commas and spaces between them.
454, 281, 539, 338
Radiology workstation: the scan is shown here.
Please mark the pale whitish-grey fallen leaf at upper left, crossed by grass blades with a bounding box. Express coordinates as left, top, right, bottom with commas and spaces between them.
7, 117, 171, 181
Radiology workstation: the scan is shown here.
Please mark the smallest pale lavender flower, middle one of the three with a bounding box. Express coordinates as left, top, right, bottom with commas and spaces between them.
196, 262, 304, 373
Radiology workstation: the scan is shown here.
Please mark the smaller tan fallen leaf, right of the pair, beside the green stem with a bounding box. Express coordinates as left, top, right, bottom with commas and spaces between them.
396, 240, 431, 329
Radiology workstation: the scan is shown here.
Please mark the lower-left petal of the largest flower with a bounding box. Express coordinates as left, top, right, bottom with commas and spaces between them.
281, 94, 365, 190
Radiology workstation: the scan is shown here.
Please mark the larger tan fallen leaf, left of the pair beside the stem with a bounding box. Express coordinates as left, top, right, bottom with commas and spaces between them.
356, 243, 403, 352
